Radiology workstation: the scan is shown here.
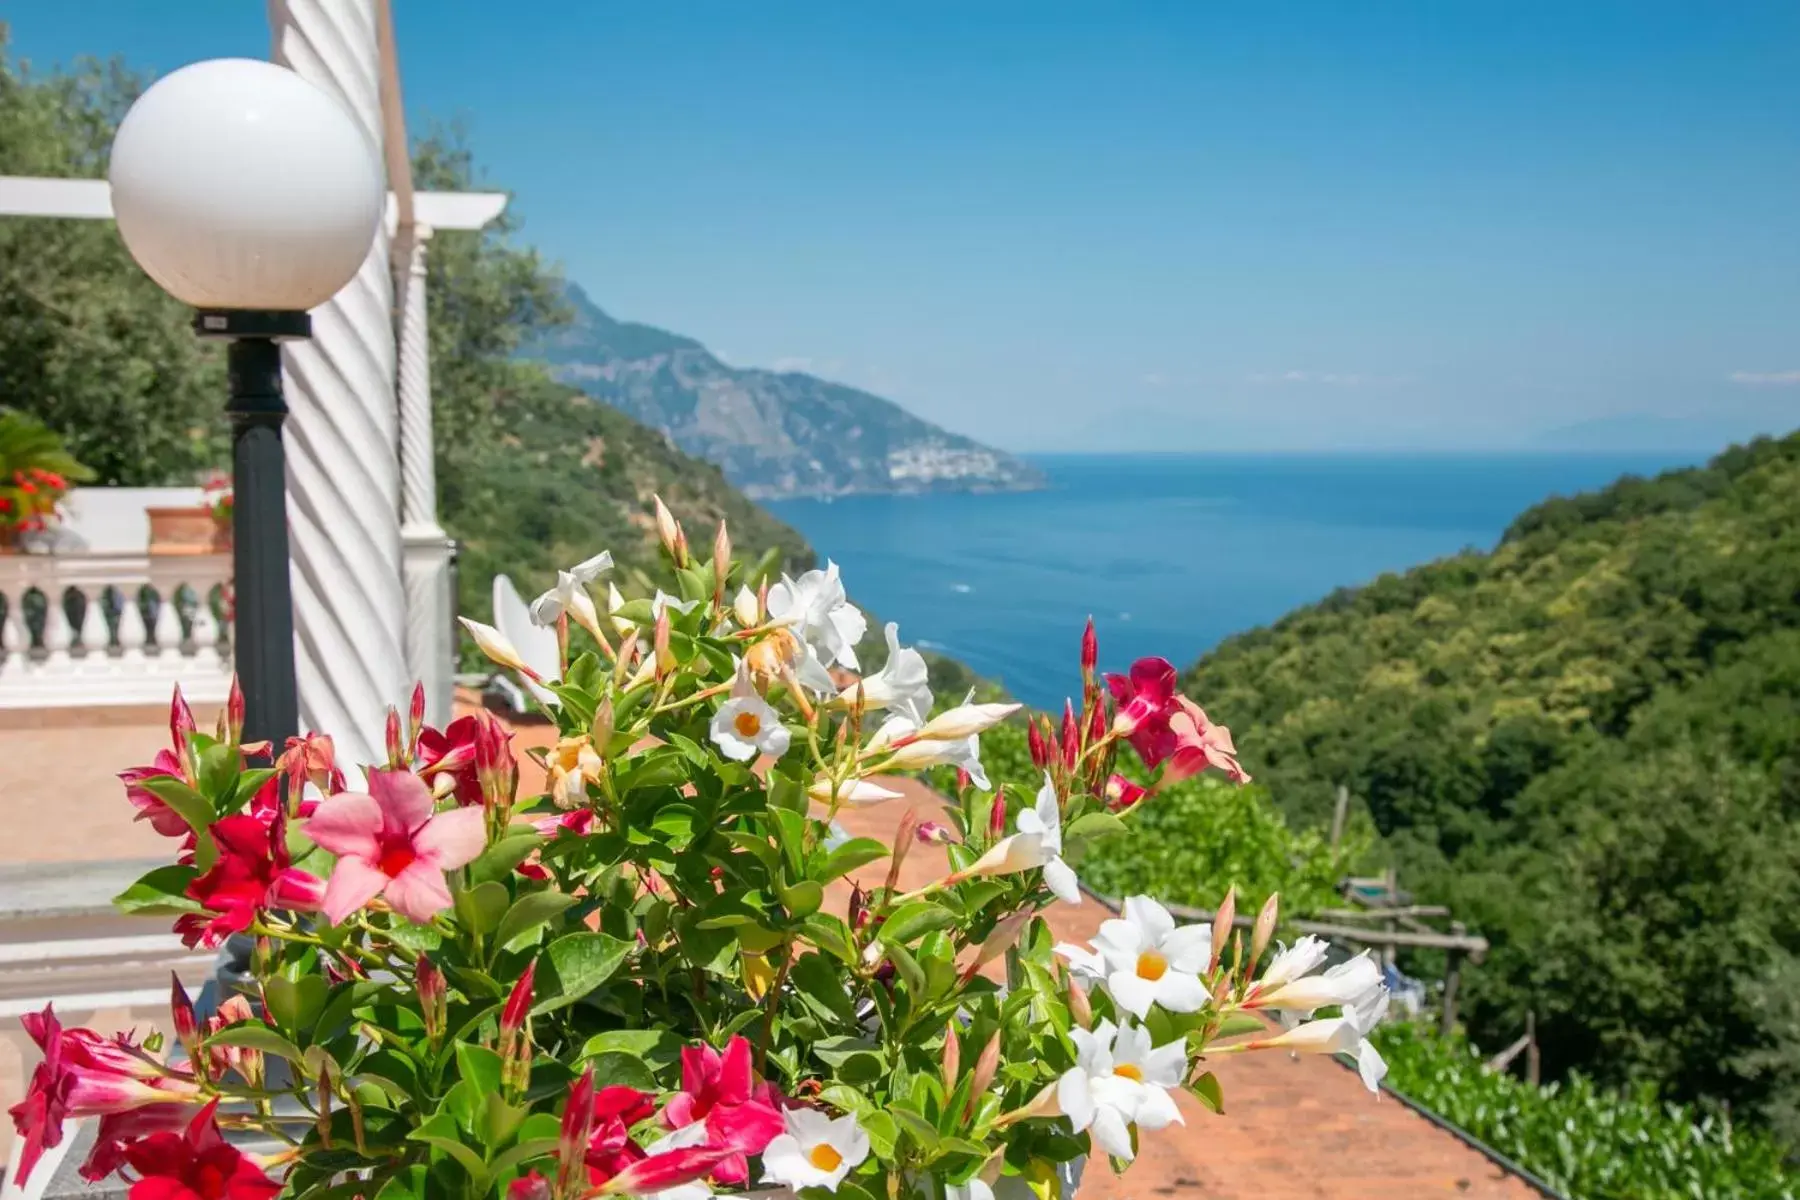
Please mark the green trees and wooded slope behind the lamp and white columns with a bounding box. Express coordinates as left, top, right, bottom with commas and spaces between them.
0, 23, 812, 629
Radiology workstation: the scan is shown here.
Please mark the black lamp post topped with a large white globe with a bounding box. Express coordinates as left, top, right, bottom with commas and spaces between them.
110, 59, 387, 752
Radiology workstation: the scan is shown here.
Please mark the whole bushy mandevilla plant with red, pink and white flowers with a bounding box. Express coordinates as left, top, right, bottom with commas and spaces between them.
13, 500, 1386, 1200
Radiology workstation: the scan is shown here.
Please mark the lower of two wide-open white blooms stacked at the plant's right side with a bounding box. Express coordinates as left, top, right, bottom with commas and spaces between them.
1057, 1020, 1188, 1160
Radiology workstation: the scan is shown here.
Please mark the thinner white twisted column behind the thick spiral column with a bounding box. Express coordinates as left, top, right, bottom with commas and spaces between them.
394, 225, 455, 727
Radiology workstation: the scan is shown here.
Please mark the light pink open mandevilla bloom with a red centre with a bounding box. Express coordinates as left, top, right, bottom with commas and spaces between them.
306, 770, 488, 925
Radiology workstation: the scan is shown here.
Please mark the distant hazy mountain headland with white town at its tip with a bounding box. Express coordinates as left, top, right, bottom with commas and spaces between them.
526, 284, 1044, 498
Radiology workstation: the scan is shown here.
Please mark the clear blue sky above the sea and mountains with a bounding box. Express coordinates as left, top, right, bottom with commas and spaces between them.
5, 0, 1800, 450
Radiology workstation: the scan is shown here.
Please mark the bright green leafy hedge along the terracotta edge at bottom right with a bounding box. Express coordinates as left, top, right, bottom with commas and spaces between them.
1375, 1022, 1800, 1200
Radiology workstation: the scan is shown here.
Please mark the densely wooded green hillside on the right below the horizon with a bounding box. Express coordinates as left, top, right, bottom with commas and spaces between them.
1183, 435, 1800, 1144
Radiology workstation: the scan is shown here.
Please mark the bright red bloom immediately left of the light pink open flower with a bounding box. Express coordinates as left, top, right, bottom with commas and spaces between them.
175, 813, 326, 946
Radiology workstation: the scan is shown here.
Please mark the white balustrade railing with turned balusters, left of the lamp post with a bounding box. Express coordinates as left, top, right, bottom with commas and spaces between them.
0, 552, 232, 709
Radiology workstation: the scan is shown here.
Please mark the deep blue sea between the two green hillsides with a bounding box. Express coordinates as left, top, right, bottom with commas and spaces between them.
767, 452, 1705, 707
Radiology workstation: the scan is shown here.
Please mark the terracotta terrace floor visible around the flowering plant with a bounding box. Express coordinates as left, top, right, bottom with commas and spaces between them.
0, 711, 1537, 1200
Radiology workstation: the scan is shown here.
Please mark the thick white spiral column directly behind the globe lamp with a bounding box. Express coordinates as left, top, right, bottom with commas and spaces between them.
268, 0, 407, 765
